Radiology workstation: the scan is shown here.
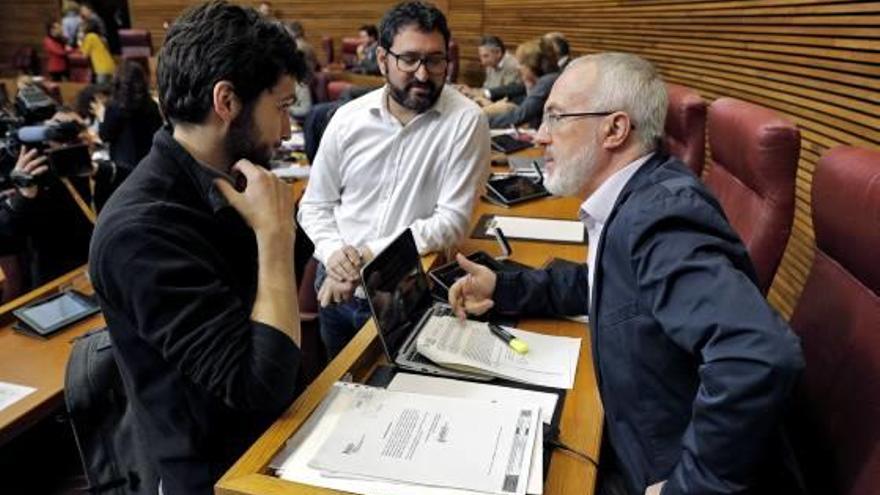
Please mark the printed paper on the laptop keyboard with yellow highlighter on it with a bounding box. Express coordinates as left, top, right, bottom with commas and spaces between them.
416, 316, 581, 389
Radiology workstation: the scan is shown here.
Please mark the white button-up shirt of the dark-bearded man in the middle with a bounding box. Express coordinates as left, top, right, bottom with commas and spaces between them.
298, 88, 489, 263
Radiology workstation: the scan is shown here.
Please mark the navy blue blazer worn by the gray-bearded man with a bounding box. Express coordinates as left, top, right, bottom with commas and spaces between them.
494, 154, 803, 495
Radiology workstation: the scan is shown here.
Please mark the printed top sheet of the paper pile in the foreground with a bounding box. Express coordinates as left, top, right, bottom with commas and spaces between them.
309, 387, 540, 495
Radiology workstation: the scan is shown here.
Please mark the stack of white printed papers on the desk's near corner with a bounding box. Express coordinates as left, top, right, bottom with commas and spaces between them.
270, 381, 555, 495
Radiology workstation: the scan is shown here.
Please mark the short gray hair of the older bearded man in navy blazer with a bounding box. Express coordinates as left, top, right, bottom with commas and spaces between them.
566, 52, 668, 151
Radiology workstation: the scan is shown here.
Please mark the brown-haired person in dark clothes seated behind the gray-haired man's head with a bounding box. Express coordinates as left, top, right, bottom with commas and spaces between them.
483, 38, 559, 129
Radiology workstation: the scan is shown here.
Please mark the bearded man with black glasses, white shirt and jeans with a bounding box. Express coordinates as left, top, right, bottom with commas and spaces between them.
299, 2, 489, 358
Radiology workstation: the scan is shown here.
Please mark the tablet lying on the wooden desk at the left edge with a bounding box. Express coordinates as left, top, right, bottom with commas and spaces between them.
12, 290, 101, 337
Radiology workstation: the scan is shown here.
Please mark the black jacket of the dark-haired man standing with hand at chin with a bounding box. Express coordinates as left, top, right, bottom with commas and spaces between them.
90, 130, 300, 495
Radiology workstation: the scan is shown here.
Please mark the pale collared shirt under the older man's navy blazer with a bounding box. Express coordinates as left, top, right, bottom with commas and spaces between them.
578, 153, 653, 303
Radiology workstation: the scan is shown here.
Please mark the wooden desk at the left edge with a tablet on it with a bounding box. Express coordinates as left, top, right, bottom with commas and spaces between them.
0, 267, 104, 446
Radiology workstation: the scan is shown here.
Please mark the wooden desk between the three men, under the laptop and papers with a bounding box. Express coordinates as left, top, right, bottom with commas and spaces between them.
215, 189, 603, 495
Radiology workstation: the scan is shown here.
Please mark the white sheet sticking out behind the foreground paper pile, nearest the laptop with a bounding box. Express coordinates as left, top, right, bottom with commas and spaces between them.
388, 373, 559, 495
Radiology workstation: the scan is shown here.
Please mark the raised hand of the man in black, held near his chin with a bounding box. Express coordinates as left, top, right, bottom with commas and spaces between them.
214, 160, 296, 242
